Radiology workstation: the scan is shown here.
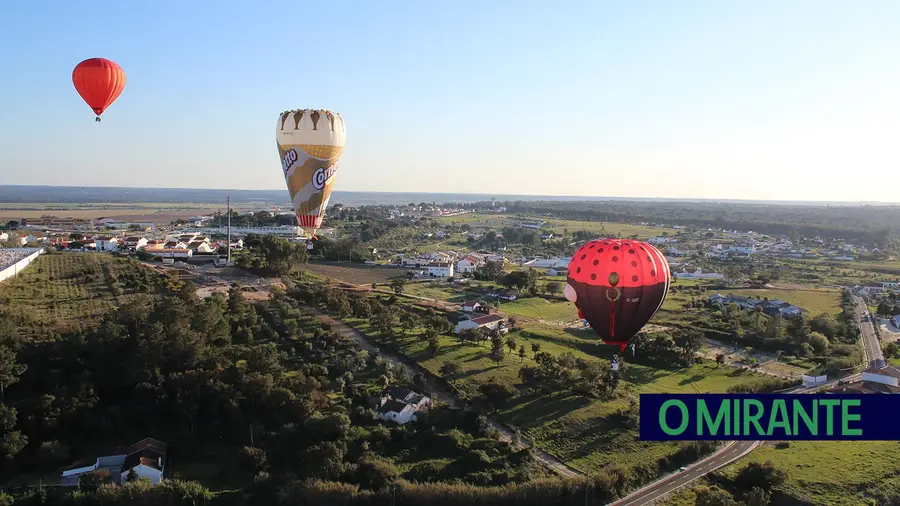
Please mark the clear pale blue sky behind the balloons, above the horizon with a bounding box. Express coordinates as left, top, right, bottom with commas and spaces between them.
0, 0, 900, 201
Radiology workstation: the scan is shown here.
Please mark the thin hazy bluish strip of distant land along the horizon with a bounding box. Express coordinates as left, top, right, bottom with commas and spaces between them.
0, 185, 892, 209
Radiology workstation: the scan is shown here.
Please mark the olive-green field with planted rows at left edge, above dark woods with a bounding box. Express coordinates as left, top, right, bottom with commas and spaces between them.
0, 253, 157, 336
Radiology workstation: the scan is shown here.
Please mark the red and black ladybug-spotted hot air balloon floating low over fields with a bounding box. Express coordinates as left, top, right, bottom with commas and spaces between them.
564, 239, 671, 353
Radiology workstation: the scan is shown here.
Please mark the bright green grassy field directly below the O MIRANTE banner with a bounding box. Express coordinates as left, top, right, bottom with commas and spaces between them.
725, 441, 900, 506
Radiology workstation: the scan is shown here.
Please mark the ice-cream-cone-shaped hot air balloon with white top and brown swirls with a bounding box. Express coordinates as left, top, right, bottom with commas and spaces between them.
275, 109, 347, 238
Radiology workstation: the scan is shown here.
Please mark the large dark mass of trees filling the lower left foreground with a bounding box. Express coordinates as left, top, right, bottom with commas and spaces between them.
0, 260, 592, 504
